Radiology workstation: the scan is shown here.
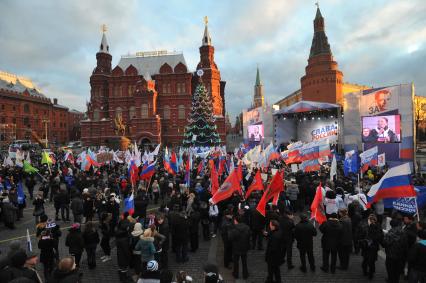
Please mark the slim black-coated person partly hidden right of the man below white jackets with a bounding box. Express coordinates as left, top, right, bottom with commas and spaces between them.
338, 208, 352, 270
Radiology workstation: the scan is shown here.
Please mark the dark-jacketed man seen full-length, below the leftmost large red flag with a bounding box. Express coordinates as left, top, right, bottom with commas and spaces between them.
228, 216, 250, 279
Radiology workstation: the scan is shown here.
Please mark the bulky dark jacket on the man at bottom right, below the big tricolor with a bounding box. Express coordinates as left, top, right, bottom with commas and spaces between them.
383, 226, 408, 259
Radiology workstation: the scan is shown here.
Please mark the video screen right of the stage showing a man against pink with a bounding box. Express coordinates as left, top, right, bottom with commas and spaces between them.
362, 115, 401, 143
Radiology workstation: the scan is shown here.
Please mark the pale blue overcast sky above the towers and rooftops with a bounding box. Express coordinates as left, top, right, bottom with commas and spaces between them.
0, 0, 426, 122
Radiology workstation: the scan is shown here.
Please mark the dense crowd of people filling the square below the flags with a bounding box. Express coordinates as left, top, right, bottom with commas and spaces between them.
0, 149, 426, 283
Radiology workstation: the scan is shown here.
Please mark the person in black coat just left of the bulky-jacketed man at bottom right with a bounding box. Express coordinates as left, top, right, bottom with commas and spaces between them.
359, 214, 383, 279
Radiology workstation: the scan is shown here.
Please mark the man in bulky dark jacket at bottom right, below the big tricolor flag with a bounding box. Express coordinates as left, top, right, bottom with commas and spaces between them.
383, 219, 408, 283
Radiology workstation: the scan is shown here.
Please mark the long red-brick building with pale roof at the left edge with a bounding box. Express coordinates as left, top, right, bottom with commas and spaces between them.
0, 72, 82, 146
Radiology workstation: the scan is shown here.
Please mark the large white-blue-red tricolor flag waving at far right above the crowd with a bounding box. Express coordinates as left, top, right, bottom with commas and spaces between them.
367, 163, 416, 207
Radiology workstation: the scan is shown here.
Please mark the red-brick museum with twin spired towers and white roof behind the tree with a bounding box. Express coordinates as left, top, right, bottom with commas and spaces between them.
81, 21, 225, 146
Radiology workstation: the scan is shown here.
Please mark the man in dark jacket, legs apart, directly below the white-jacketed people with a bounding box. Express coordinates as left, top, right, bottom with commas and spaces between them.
319, 213, 342, 273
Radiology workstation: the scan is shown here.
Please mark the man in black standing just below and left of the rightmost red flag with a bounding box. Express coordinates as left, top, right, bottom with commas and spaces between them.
294, 214, 317, 272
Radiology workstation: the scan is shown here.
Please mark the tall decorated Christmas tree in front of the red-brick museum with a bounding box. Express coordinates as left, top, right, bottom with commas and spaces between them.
183, 79, 221, 147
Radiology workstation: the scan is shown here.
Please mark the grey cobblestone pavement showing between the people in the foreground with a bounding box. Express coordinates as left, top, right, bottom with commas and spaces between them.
0, 185, 386, 283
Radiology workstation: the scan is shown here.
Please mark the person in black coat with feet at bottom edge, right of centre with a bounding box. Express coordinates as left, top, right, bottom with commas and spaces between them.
265, 220, 284, 283
